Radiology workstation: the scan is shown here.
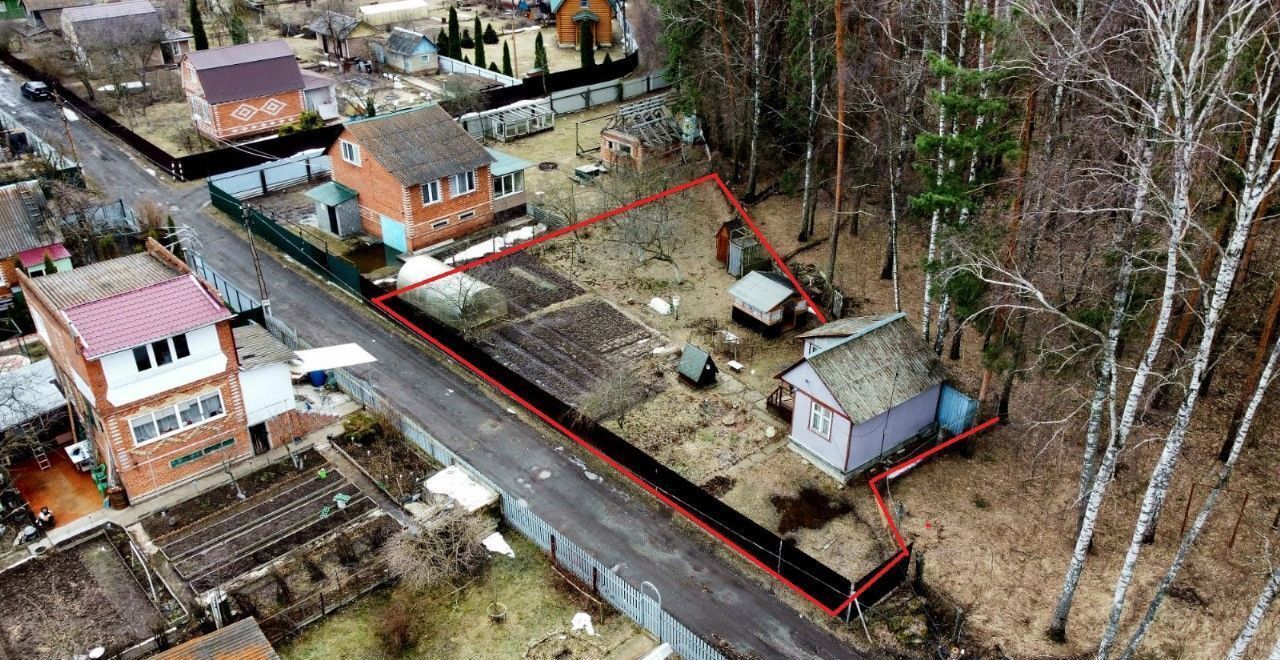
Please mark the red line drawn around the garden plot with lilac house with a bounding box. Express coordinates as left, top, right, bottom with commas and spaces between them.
370, 173, 998, 617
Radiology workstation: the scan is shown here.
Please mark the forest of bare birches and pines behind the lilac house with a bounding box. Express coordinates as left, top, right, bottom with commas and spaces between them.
658, 0, 1280, 657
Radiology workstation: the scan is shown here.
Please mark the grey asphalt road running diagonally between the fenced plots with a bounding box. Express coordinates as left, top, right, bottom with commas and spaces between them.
0, 70, 861, 659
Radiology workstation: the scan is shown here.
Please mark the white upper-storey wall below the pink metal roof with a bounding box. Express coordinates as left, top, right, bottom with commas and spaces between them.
101, 325, 227, 405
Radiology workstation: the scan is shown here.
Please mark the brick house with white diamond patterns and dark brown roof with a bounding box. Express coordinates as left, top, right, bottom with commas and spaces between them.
182, 40, 338, 139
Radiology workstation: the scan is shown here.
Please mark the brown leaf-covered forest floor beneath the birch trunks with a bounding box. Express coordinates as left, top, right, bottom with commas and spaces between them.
749, 182, 1280, 659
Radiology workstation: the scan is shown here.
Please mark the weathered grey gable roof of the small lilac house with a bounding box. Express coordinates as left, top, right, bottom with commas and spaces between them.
783, 313, 946, 425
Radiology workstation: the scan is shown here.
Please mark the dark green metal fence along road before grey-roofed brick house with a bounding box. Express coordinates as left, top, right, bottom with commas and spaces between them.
207, 182, 361, 297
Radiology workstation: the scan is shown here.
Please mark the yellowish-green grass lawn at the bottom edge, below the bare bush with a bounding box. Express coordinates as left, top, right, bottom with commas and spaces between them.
279, 532, 645, 660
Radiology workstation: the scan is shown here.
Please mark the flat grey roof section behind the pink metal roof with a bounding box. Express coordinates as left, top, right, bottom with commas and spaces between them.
31, 252, 180, 310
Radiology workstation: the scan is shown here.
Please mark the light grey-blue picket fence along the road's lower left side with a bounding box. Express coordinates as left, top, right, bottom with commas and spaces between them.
257, 316, 724, 660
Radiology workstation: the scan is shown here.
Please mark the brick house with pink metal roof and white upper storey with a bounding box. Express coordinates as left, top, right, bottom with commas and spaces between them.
19, 239, 293, 500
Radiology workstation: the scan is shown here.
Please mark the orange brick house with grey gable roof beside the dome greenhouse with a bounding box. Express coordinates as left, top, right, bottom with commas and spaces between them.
308, 104, 527, 252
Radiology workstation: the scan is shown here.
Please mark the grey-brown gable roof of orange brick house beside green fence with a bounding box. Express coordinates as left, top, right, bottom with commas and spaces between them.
347, 104, 494, 188
